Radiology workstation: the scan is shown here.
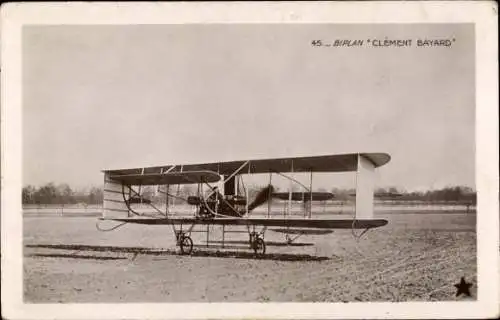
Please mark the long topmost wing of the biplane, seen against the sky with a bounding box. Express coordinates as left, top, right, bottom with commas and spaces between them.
106, 153, 391, 175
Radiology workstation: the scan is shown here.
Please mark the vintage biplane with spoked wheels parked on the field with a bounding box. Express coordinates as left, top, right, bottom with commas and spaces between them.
99, 153, 390, 255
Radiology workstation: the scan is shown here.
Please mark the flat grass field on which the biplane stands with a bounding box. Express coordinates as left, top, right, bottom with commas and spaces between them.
24, 212, 477, 303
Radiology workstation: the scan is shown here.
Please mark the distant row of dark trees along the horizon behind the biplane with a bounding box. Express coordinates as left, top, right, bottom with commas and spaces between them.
22, 182, 476, 205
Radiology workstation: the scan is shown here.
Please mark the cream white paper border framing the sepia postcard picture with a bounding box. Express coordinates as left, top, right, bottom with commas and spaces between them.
1, 1, 499, 319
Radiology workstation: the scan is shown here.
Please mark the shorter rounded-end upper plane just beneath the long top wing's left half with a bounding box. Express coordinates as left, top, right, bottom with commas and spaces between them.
109, 170, 220, 185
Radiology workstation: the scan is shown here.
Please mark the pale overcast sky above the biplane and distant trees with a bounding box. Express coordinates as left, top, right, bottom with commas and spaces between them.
23, 24, 475, 190
